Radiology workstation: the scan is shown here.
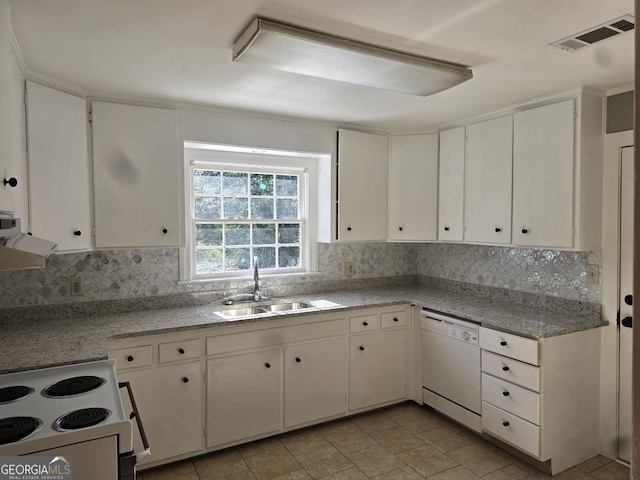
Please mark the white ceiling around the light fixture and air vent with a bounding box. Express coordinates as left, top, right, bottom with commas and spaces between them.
11, 0, 634, 132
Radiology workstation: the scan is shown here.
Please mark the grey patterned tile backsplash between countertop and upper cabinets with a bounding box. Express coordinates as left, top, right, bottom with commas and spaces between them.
0, 242, 601, 308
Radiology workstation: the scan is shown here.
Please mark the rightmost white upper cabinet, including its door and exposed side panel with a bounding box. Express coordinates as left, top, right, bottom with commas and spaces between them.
513, 93, 603, 250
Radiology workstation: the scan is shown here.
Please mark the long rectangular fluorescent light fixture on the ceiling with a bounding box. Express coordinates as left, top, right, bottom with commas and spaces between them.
233, 17, 473, 97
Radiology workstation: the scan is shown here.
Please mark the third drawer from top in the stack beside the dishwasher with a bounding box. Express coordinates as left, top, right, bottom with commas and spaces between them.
482, 373, 540, 425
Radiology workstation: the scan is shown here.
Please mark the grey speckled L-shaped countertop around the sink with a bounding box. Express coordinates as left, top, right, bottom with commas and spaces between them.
0, 286, 606, 373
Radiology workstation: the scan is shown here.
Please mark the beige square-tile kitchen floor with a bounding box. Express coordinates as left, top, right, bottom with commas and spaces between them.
138, 403, 629, 480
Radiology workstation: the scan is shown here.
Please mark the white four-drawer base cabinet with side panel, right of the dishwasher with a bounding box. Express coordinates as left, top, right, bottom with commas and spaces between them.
480, 327, 600, 474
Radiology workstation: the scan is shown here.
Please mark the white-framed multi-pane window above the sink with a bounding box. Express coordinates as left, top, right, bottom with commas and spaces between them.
182, 149, 315, 281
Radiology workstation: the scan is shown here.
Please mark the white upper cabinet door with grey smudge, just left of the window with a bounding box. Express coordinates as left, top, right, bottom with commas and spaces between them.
92, 102, 182, 248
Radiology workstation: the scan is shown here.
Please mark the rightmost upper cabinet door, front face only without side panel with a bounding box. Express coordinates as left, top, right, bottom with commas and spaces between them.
513, 100, 575, 248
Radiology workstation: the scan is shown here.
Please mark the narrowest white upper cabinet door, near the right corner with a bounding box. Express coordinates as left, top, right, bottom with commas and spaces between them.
438, 127, 465, 242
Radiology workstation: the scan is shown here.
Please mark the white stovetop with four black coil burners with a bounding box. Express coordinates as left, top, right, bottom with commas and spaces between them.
0, 360, 132, 456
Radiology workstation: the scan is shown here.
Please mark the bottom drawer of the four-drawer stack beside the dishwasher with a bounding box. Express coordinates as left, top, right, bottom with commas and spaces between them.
482, 402, 540, 458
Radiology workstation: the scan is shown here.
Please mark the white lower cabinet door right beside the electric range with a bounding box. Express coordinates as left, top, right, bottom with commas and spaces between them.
118, 361, 204, 465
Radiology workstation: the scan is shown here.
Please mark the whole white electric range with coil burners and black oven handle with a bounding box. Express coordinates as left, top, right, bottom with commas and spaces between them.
0, 360, 148, 480
